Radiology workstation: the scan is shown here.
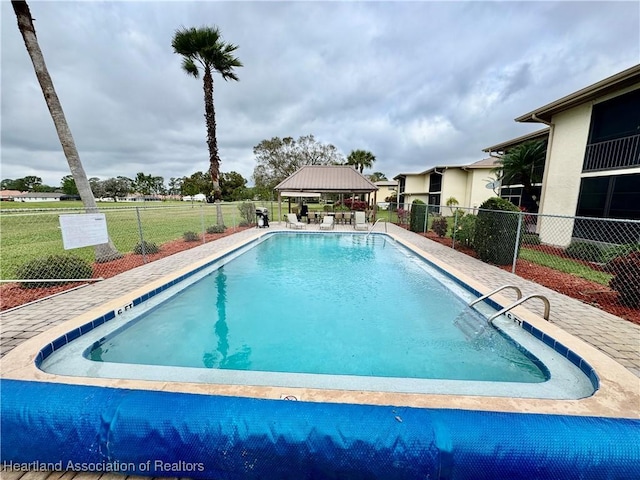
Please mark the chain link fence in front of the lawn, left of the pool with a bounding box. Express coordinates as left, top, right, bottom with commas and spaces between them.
0, 202, 273, 310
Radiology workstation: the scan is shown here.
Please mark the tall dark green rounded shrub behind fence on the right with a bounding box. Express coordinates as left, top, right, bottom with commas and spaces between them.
473, 197, 520, 265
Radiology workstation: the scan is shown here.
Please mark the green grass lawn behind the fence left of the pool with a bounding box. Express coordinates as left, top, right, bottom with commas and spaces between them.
0, 202, 277, 280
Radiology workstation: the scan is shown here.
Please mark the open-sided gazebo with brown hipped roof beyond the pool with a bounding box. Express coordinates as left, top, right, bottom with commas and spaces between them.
275, 165, 378, 223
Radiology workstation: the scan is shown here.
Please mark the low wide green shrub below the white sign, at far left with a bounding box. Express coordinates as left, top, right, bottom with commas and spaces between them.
16, 255, 93, 288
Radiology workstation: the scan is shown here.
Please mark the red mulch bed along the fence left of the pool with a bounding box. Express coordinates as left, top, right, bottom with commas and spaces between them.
0, 227, 251, 311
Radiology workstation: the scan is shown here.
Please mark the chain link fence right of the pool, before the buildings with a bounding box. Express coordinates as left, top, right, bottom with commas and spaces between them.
378, 203, 640, 323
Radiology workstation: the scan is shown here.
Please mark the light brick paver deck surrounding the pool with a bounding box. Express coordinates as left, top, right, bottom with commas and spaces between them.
0, 223, 640, 480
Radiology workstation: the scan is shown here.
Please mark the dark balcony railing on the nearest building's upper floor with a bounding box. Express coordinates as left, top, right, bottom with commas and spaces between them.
582, 134, 640, 172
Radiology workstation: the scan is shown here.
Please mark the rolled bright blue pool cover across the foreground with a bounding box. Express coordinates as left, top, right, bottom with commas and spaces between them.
0, 380, 640, 480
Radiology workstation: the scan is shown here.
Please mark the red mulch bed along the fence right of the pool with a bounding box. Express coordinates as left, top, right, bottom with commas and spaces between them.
421, 232, 640, 325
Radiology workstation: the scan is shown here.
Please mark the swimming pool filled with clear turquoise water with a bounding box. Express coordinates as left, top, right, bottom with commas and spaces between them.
40, 233, 597, 398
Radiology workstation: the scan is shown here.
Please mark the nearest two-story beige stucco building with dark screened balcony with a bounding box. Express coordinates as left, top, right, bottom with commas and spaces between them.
485, 65, 640, 246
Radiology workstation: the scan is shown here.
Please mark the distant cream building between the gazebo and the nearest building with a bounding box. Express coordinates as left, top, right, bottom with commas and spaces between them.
393, 158, 496, 212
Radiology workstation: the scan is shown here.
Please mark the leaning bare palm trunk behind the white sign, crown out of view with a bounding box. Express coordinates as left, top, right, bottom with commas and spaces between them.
11, 0, 122, 262
